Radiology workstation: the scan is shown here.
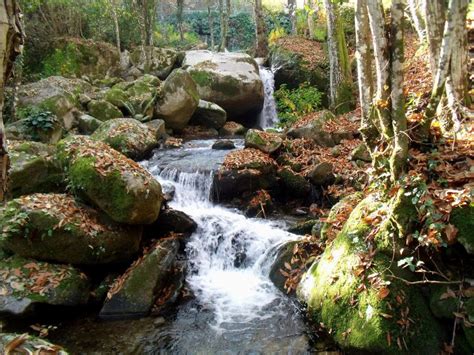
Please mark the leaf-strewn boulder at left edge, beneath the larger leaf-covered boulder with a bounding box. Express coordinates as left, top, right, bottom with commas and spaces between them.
0, 256, 90, 316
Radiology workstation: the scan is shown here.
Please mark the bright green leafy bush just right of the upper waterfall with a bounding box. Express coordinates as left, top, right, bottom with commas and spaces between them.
275, 83, 322, 127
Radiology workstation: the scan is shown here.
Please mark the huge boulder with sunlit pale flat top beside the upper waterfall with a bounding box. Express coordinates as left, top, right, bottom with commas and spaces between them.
183, 50, 264, 120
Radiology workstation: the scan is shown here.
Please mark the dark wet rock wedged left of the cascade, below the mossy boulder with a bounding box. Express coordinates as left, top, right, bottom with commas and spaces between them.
144, 208, 197, 238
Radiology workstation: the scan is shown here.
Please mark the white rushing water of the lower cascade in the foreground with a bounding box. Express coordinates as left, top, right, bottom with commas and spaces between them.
145, 141, 298, 330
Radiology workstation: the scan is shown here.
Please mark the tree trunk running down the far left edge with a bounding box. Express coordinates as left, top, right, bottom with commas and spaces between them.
0, 0, 24, 201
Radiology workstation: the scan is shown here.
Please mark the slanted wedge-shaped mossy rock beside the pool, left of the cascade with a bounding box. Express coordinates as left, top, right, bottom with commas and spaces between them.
100, 239, 179, 319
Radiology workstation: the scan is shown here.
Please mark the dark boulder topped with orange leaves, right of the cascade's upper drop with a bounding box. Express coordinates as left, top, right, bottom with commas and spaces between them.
212, 148, 278, 201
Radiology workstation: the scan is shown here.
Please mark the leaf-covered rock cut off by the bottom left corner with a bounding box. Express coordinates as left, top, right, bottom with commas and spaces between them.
0, 333, 68, 355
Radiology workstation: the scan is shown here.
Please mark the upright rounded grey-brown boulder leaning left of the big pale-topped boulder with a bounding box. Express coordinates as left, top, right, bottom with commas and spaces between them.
155, 69, 199, 130
